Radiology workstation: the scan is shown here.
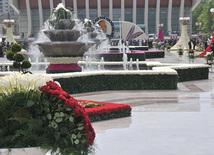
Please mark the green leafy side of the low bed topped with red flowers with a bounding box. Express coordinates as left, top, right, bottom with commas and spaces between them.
89, 109, 131, 122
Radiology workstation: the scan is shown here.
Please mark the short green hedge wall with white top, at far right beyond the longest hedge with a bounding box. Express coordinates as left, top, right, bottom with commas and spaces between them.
175, 67, 209, 82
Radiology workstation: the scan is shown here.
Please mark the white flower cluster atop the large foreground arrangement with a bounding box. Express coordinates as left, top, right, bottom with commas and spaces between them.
0, 72, 53, 94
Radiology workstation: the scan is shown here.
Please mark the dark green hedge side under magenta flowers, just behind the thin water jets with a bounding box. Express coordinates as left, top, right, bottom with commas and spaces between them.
89, 53, 146, 61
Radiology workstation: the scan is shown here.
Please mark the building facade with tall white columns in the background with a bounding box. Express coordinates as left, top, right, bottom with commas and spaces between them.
9, 0, 201, 36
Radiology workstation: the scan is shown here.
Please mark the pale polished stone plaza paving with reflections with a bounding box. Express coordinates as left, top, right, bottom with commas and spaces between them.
73, 51, 214, 155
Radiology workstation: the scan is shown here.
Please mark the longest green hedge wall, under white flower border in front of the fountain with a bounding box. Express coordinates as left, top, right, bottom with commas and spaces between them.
54, 74, 178, 94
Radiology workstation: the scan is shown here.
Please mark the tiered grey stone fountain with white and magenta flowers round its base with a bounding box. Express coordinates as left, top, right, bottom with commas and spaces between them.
37, 3, 95, 73
